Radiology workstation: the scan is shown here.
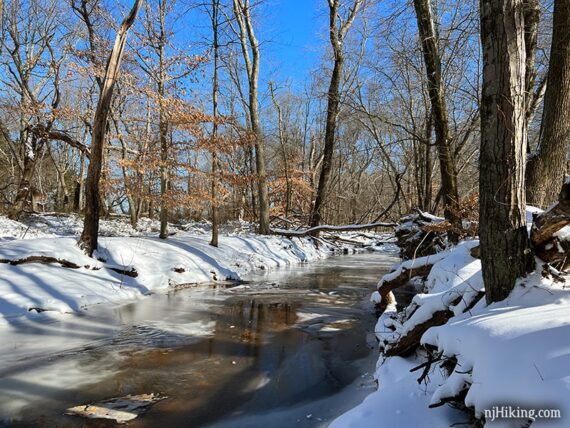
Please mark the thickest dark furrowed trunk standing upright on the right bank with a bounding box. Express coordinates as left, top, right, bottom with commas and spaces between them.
479, 0, 533, 303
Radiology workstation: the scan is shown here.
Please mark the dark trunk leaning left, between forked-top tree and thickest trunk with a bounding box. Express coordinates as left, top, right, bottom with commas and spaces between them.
414, 0, 461, 241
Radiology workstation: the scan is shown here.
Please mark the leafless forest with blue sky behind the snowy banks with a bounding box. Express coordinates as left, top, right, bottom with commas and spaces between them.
0, 0, 568, 253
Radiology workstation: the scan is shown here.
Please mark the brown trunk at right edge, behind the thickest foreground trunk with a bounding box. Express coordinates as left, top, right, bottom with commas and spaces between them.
526, 0, 570, 208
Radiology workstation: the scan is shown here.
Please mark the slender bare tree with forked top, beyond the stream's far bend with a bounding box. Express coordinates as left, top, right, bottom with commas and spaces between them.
310, 0, 363, 227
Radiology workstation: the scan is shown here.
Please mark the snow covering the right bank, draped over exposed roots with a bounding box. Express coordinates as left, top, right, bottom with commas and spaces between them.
331, 212, 570, 428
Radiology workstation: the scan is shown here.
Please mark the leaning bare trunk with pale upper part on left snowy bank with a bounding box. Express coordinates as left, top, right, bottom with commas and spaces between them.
79, 0, 142, 256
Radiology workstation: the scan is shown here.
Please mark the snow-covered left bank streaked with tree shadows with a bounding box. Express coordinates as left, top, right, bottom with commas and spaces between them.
0, 215, 390, 327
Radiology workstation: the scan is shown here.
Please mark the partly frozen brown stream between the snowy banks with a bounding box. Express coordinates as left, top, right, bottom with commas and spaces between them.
0, 252, 400, 428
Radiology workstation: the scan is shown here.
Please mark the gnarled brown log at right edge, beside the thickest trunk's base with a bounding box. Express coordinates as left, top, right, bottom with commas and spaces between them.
530, 181, 570, 270
